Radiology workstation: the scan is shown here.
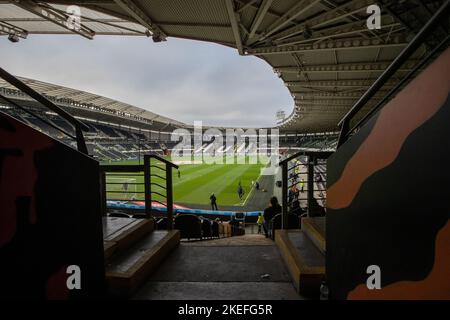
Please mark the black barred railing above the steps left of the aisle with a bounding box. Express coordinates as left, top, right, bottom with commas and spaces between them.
100, 154, 178, 230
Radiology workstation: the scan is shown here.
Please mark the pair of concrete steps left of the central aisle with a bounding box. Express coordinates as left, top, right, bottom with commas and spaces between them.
103, 217, 180, 298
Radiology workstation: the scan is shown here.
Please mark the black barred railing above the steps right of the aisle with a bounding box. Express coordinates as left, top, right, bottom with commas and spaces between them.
279, 151, 332, 229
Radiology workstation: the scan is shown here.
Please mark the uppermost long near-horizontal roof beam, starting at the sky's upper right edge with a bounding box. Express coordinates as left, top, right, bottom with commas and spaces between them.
247, 36, 408, 55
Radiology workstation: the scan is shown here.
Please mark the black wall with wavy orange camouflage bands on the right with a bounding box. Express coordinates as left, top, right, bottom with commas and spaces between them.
327, 49, 450, 299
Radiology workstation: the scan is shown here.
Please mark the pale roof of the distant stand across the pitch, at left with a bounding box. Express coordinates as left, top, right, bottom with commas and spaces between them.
0, 77, 187, 127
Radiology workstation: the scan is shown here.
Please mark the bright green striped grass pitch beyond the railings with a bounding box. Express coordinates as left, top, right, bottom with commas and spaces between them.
104, 159, 263, 209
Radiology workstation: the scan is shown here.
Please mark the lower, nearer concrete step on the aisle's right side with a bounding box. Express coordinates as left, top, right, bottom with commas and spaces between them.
275, 230, 325, 298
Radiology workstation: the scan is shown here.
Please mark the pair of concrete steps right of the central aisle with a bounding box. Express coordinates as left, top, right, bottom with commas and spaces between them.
275, 217, 326, 298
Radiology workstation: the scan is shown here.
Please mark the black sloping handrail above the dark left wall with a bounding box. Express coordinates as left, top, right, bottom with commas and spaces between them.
0, 68, 89, 154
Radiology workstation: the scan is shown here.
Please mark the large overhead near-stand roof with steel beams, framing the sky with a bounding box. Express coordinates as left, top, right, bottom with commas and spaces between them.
0, 0, 448, 132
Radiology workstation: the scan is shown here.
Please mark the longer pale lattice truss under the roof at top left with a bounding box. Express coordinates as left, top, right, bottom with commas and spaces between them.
13, 0, 95, 40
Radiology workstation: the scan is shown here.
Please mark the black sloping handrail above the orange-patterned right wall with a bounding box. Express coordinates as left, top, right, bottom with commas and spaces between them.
337, 0, 450, 148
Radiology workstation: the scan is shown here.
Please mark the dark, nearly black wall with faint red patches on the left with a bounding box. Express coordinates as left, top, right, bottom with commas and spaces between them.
0, 112, 104, 299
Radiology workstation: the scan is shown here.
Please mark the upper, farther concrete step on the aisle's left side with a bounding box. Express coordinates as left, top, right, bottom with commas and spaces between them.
103, 217, 154, 261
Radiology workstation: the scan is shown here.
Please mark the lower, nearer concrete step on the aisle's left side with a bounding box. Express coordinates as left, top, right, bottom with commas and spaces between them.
106, 230, 180, 297
